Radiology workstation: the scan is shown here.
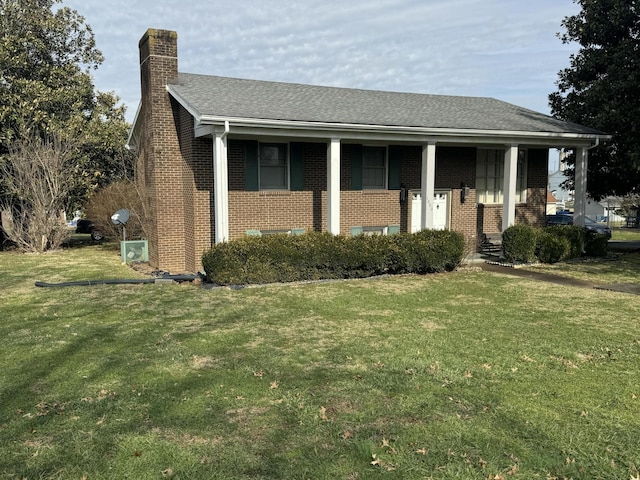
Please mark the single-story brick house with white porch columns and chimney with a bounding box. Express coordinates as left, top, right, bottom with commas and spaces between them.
128, 29, 606, 272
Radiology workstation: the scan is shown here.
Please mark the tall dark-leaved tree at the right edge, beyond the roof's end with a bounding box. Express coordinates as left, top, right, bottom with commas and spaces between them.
549, 0, 640, 199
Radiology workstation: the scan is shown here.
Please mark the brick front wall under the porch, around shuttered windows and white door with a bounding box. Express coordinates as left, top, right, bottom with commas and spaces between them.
228, 140, 476, 244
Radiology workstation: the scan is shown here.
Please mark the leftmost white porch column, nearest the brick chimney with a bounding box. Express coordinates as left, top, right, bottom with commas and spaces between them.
213, 131, 229, 243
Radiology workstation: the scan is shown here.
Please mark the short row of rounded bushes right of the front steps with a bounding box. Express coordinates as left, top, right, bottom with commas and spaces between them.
502, 225, 608, 263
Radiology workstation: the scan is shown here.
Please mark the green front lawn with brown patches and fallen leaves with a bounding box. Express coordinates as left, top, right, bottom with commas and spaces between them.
0, 245, 640, 480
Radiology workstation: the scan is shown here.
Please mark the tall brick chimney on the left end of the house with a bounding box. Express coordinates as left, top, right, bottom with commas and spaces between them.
138, 28, 187, 272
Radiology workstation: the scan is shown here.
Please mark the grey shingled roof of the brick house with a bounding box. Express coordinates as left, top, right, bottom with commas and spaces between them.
168, 73, 604, 136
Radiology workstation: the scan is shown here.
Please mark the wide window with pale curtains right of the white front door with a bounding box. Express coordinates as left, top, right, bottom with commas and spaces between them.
476, 149, 527, 204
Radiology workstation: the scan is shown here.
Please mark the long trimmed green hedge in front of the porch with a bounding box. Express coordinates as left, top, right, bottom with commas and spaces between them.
202, 230, 464, 285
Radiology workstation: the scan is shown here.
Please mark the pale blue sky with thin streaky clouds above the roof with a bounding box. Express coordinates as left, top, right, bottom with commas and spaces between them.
54, 0, 580, 169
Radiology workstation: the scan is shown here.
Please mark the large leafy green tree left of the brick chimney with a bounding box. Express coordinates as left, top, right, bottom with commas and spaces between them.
0, 0, 132, 210
